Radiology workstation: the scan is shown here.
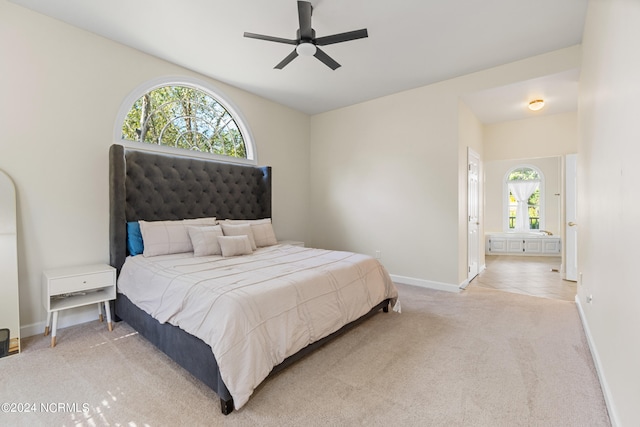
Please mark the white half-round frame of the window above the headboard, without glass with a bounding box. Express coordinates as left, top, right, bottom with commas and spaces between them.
113, 76, 258, 165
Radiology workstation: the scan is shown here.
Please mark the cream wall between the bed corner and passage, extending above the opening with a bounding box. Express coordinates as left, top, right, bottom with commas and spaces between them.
309, 46, 580, 288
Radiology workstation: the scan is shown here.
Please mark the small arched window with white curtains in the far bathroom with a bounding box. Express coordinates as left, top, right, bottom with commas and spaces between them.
505, 165, 544, 231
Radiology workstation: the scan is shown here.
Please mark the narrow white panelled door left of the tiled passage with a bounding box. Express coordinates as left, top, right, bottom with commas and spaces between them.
467, 149, 480, 282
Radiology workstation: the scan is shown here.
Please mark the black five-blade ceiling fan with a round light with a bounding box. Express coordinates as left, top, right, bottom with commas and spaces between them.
244, 1, 369, 70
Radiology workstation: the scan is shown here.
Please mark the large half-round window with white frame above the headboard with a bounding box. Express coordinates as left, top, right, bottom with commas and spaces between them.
117, 79, 256, 164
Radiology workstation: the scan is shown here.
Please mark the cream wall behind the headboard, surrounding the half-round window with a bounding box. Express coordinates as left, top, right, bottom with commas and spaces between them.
0, 0, 310, 336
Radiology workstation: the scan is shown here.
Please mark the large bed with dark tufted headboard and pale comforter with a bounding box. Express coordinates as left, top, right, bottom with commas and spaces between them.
109, 144, 399, 415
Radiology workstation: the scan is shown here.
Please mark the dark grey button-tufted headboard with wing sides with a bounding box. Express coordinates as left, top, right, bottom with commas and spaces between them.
109, 144, 271, 273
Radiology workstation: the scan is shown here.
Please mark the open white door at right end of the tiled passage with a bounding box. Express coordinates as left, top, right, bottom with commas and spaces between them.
564, 154, 578, 282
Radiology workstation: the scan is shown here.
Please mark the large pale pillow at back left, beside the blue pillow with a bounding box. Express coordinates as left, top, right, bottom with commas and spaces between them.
138, 218, 216, 257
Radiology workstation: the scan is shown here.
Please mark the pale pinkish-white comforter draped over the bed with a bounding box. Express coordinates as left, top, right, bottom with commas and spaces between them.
118, 245, 399, 409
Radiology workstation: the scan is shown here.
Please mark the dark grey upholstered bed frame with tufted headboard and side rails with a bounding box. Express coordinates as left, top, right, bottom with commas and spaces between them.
109, 144, 389, 415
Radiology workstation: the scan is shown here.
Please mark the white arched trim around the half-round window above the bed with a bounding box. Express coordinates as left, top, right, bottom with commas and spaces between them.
113, 76, 258, 165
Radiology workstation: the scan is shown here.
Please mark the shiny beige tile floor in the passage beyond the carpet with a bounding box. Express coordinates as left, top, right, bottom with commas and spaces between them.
469, 255, 576, 301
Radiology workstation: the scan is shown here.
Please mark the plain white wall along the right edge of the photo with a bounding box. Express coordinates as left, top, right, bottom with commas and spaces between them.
577, 0, 640, 426
